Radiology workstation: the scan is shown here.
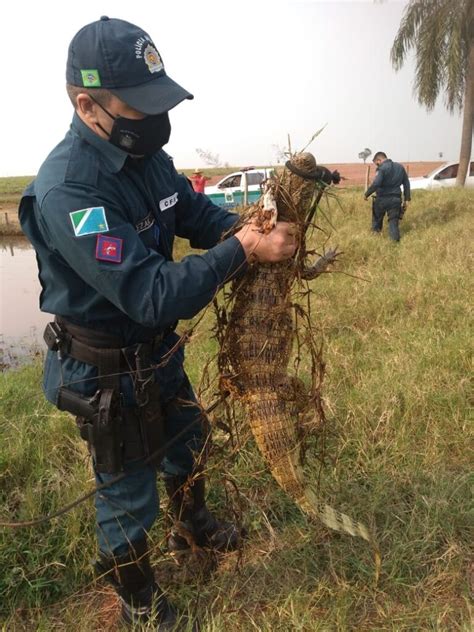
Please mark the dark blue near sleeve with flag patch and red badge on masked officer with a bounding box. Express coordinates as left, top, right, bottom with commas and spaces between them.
39, 184, 246, 328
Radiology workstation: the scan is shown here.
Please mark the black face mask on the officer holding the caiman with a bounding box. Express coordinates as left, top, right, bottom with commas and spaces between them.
91, 97, 171, 156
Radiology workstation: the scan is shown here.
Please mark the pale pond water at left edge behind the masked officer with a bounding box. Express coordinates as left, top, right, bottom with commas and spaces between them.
0, 237, 51, 370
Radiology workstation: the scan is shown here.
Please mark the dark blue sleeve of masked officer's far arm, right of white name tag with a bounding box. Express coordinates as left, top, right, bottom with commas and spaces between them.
176, 174, 239, 249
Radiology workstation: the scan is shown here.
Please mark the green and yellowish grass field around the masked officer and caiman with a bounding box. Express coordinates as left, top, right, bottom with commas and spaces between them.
0, 190, 474, 632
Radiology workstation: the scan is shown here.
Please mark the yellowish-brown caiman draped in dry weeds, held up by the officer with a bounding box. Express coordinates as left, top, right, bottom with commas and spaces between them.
219, 153, 377, 572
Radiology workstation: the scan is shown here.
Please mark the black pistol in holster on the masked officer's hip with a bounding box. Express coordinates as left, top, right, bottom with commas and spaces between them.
58, 386, 123, 474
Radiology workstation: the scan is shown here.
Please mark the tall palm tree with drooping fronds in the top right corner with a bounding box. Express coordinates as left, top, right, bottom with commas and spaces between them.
390, 0, 474, 186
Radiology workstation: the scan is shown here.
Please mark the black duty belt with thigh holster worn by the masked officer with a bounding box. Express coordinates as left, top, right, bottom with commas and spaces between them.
44, 319, 168, 474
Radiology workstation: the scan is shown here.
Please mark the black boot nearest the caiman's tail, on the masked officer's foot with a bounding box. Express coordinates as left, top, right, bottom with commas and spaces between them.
164, 476, 244, 552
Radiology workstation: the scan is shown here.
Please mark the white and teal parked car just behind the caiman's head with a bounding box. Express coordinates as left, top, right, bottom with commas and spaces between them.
205, 167, 274, 208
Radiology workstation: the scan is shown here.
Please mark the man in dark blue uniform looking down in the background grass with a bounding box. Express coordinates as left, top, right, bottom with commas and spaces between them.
364, 151, 410, 241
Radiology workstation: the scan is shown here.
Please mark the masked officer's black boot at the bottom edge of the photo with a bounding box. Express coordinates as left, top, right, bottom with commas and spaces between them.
95, 540, 199, 632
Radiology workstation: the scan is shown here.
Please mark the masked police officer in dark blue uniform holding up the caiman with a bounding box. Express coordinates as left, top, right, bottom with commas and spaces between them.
20, 17, 296, 630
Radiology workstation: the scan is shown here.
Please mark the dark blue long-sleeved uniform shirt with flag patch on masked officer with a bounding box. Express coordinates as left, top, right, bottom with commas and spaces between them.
20, 114, 246, 401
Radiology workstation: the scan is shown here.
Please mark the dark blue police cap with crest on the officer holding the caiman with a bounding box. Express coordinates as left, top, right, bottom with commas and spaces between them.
66, 16, 194, 114
